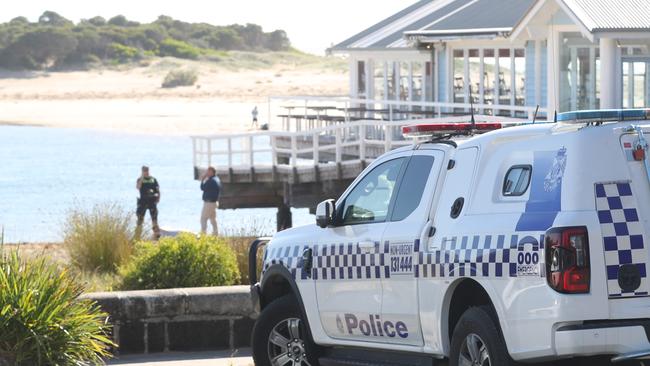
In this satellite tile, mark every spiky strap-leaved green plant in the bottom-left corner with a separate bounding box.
[0,252,115,366]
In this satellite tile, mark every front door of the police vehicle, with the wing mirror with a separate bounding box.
[312,151,410,342]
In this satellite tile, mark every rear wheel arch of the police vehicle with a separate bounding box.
[440,278,508,355]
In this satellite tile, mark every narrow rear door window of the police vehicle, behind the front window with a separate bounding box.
[391,155,433,221]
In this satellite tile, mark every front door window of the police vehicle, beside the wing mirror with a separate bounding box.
[339,158,404,225]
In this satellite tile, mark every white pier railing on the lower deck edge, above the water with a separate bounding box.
[192,120,413,171]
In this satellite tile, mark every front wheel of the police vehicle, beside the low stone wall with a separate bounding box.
[252,295,318,366]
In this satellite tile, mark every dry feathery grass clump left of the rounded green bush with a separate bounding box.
[63,203,136,272]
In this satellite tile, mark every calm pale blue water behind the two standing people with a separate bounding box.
[0,126,313,242]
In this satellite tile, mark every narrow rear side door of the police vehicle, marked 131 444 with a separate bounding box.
[380,150,445,345]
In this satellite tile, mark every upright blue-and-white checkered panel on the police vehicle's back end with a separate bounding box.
[595,182,650,298]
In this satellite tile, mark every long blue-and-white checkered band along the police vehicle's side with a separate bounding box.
[264,234,545,281]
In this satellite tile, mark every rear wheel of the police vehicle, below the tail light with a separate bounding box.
[449,306,515,366]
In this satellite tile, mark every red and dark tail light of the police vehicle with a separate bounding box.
[545,226,591,294]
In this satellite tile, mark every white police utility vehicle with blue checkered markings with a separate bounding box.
[246,109,650,366]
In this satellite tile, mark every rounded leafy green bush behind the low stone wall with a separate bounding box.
[120,233,239,290]
